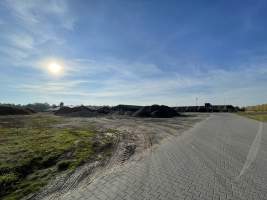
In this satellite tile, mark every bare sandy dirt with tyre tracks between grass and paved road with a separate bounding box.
[30,113,208,200]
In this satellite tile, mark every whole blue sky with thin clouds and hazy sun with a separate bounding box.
[0,0,267,106]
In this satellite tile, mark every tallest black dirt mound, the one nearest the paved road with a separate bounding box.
[133,105,179,118]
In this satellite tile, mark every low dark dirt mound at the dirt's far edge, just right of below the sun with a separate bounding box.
[55,106,98,117]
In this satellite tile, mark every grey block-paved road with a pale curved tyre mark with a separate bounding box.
[53,114,267,200]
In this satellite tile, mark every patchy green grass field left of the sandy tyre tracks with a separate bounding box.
[0,115,114,200]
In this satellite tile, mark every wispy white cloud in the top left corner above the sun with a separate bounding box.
[0,0,76,66]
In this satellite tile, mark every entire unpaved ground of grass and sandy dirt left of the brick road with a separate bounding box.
[0,113,204,200]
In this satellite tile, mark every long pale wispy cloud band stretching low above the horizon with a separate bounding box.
[12,55,267,105]
